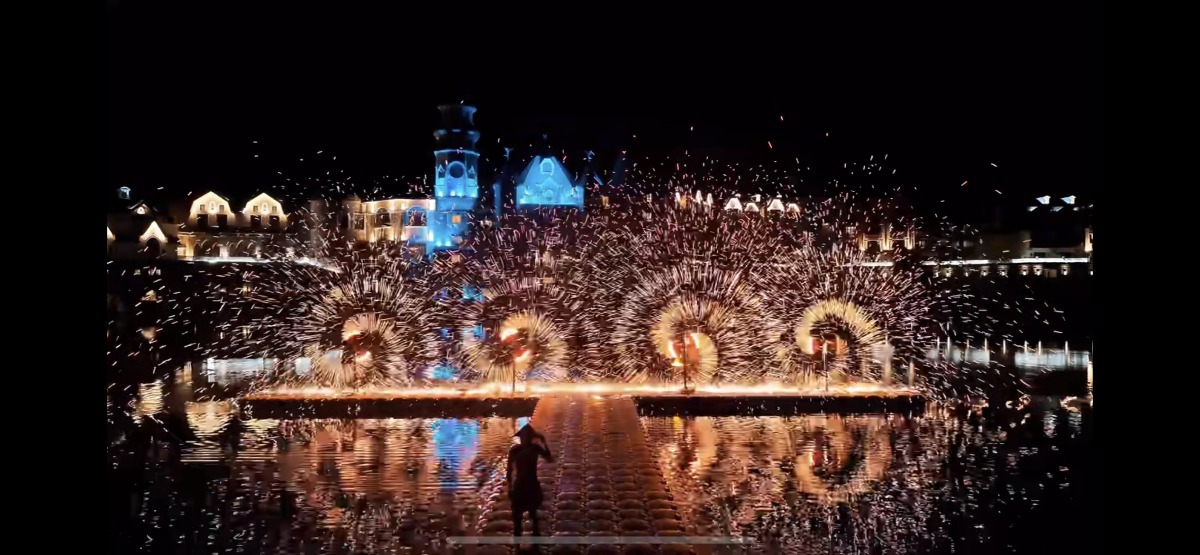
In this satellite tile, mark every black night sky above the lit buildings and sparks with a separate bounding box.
[106,1,1093,216]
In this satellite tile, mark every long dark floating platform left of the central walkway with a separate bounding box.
[239,395,539,419]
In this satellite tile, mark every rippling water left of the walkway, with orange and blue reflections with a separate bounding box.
[109,370,521,553]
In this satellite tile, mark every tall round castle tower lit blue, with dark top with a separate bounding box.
[430,105,479,250]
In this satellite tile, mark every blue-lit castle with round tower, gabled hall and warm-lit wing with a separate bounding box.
[342,105,592,256]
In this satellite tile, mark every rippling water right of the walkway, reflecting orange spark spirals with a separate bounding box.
[643,400,1091,553]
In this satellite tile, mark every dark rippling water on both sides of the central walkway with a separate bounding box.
[108,370,1092,554]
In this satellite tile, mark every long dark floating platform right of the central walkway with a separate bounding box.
[634,392,928,416]
